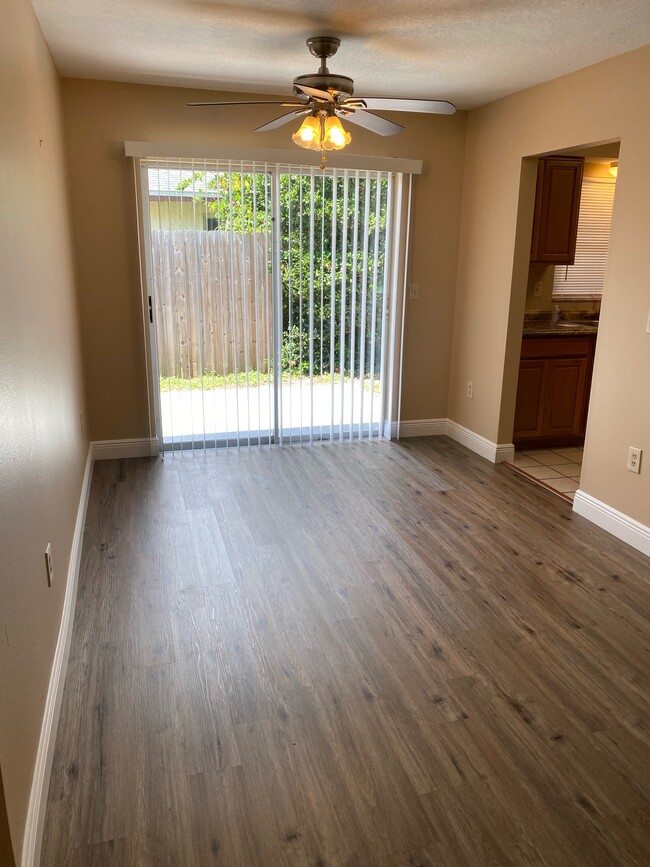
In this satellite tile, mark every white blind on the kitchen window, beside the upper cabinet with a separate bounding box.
[553,178,616,298]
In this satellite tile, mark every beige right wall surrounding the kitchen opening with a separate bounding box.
[449,47,650,525]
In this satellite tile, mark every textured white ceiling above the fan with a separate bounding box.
[32,0,650,108]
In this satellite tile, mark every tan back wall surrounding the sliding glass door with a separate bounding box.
[63,79,466,439]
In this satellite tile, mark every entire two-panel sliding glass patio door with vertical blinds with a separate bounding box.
[141,159,406,451]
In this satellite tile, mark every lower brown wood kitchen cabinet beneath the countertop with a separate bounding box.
[513,335,596,448]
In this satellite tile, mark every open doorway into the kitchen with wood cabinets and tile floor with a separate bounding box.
[509,142,619,501]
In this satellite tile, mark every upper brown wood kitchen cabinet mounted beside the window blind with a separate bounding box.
[530,157,585,265]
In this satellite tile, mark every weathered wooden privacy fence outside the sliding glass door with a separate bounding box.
[151,229,272,379]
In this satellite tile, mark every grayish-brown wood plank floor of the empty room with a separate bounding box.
[42,437,650,867]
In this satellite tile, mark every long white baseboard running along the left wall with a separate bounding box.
[20,445,93,867]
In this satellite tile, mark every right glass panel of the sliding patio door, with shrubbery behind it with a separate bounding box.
[277,169,390,441]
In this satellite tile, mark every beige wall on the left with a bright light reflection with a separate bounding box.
[0,0,87,860]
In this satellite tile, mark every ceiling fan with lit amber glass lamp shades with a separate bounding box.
[188,36,456,161]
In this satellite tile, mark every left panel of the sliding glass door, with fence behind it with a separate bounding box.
[145,160,273,450]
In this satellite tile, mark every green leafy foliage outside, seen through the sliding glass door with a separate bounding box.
[178,171,388,375]
